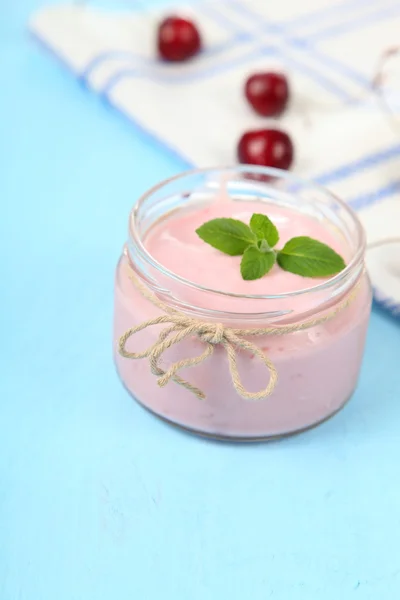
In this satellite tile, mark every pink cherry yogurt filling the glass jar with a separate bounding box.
[114,199,371,439]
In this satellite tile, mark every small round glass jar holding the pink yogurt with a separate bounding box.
[114,166,371,440]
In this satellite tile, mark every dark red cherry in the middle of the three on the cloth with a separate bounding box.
[245,73,289,117]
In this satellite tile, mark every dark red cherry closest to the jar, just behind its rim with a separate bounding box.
[237,129,294,169]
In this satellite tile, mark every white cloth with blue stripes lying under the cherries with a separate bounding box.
[30,0,400,312]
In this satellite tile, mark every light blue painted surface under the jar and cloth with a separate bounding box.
[0,0,400,600]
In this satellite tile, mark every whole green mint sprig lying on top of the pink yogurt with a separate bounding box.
[196,214,346,280]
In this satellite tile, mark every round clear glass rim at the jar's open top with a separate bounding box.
[129,164,366,300]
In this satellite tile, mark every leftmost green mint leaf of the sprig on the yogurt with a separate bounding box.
[196,218,257,256]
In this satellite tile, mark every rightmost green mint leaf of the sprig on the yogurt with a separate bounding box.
[277,236,346,277]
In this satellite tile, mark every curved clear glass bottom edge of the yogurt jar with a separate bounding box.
[121,379,353,444]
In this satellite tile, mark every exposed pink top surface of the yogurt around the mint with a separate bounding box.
[145,201,346,295]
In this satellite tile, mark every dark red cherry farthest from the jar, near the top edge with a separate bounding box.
[157,16,201,62]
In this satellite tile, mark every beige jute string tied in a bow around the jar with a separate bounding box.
[119,267,360,400]
